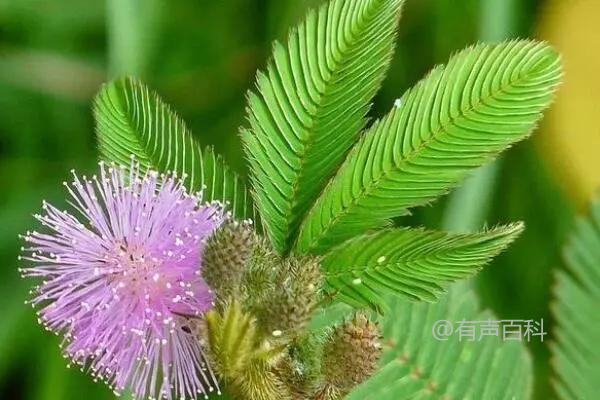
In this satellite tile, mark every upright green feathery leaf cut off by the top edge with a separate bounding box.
[242,0,403,253]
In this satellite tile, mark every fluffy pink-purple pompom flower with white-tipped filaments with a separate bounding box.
[21,162,223,399]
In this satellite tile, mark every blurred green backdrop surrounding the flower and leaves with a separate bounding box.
[0,0,600,400]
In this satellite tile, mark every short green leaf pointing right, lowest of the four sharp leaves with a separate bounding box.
[321,224,523,310]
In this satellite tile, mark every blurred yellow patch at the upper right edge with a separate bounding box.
[537,0,600,205]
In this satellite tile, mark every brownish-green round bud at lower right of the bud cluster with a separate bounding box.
[323,313,381,396]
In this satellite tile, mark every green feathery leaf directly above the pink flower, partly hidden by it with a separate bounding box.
[94,78,255,219]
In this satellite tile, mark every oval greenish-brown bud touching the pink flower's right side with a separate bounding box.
[202,220,256,302]
